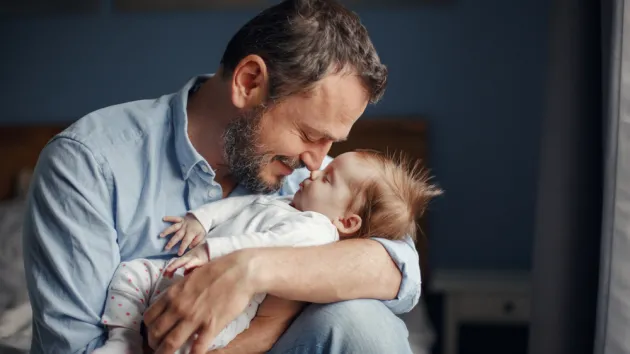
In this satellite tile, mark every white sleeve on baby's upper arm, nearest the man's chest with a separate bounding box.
[190,195,260,233]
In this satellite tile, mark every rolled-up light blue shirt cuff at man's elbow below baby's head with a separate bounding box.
[373,238,421,314]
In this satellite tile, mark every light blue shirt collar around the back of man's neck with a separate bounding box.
[171,74,213,179]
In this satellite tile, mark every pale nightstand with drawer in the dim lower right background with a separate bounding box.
[431,270,531,354]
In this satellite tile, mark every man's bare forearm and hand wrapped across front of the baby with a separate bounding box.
[144,239,419,354]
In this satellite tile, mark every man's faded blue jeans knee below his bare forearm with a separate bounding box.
[269,300,411,354]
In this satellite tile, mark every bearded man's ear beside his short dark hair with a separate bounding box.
[232,55,269,109]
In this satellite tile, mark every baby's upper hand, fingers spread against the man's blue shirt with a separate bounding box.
[160,214,206,256]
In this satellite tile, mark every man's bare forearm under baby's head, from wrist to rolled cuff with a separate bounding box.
[249,239,410,303]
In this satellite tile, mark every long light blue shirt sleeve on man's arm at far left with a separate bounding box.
[23,137,120,353]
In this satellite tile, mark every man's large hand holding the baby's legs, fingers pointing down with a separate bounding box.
[144,251,257,354]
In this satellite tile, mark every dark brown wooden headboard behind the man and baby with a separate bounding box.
[0,117,428,284]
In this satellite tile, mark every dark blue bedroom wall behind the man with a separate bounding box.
[0,0,548,269]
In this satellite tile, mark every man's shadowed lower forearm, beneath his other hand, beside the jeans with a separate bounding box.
[210,296,305,354]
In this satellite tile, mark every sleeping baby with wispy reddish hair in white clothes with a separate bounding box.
[95,150,441,353]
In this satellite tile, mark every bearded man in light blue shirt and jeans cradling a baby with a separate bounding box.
[24,0,420,353]
